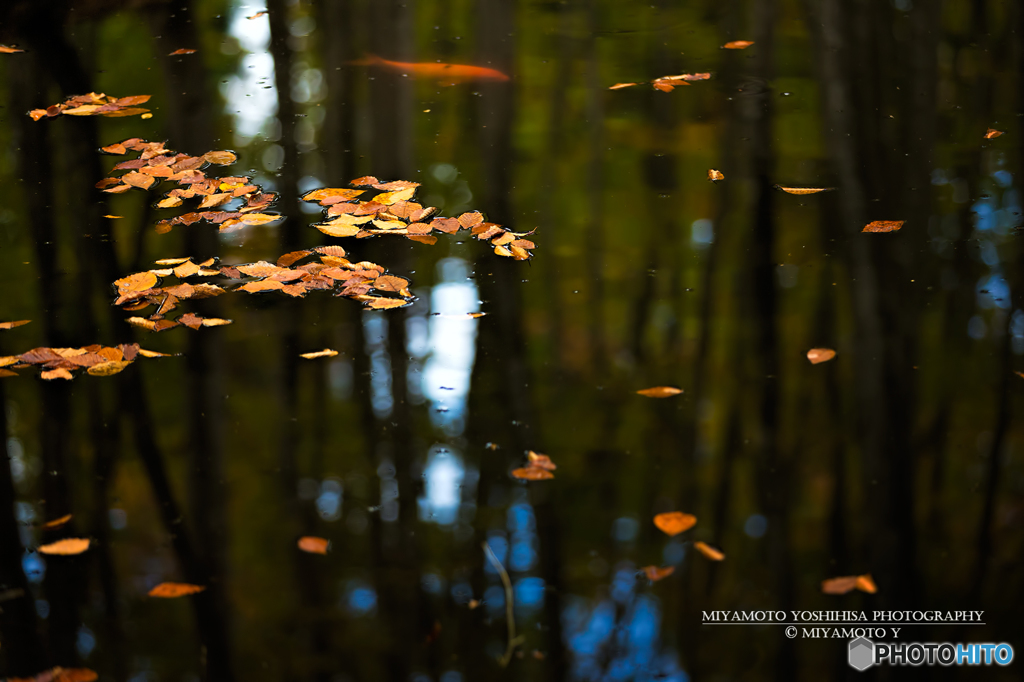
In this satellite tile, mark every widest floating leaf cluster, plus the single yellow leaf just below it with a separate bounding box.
[114,246,413,325]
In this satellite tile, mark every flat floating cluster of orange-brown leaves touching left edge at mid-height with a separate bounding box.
[0,343,169,380]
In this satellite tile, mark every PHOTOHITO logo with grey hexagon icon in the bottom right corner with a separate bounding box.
[847,637,1014,671]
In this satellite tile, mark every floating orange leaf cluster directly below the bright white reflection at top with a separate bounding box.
[96,137,282,233]
